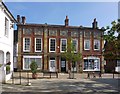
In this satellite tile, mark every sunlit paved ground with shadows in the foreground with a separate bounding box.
[2,73,120,94]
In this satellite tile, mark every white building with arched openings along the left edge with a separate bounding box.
[0,2,16,83]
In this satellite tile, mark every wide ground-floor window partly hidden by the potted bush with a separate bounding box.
[23,56,42,70]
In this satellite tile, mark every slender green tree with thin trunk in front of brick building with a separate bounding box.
[62,39,82,78]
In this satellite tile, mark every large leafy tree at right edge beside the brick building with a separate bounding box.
[104,19,120,60]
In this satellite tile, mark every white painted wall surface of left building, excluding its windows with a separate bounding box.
[0,2,14,82]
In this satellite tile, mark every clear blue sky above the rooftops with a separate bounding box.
[5,2,120,28]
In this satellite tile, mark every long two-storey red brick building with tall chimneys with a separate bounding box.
[17,15,104,72]
